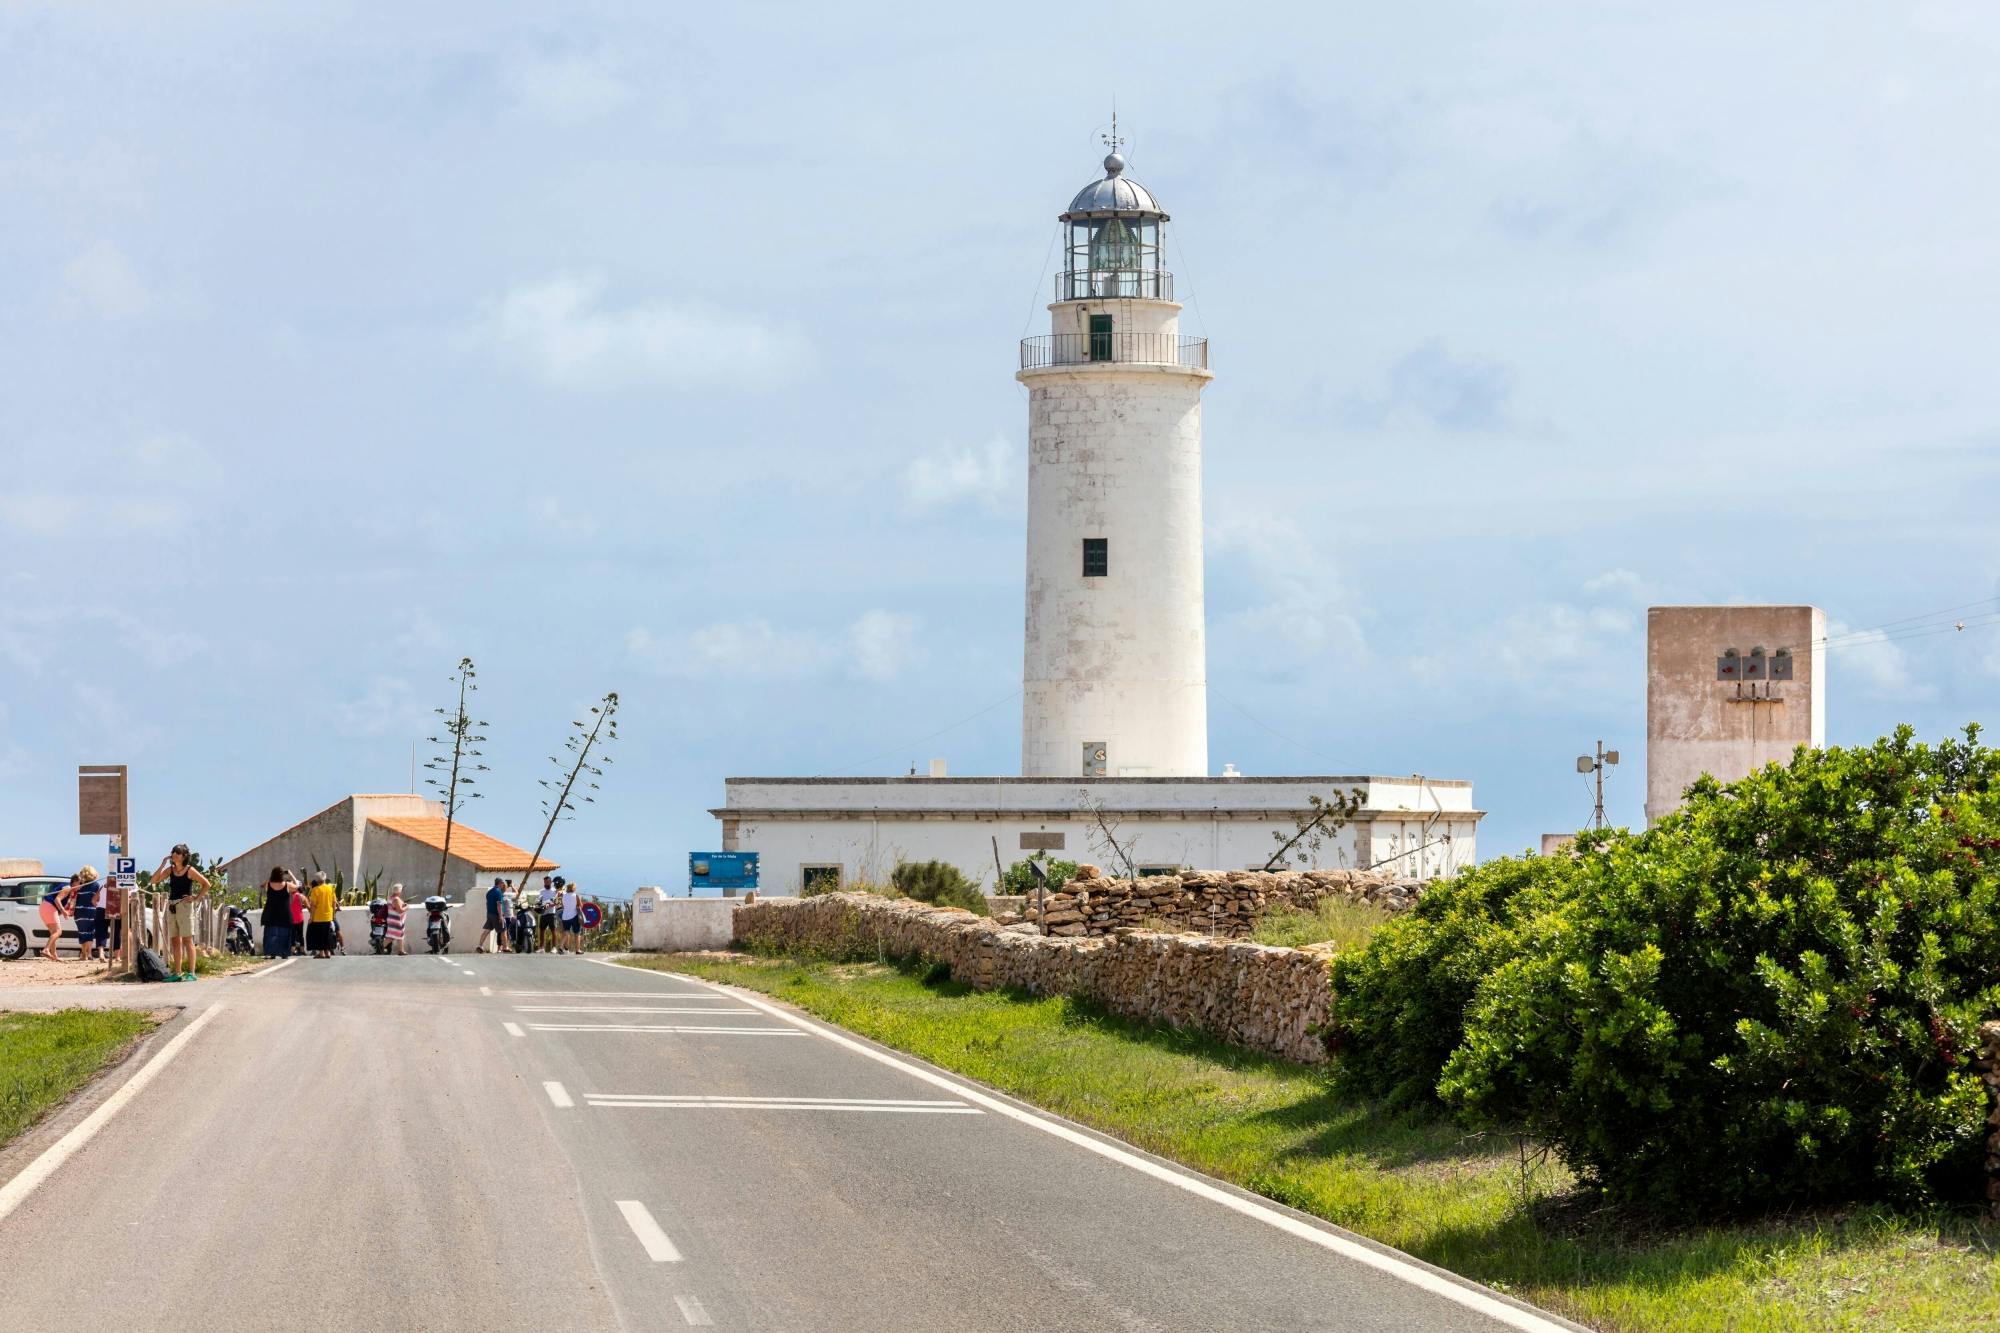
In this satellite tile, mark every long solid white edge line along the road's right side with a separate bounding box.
[590,959,1564,1333]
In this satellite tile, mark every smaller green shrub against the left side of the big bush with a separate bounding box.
[1330,857,1576,1103]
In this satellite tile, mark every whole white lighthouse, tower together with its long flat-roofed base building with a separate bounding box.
[694,140,1482,895]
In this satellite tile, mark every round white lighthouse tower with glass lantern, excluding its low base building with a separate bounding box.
[1016,140,1214,777]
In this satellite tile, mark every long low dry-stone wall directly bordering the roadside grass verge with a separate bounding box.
[736,881,1360,1065]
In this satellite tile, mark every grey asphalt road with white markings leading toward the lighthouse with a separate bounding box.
[0,955,1576,1333]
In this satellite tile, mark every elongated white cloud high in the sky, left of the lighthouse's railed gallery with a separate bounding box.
[472,274,810,390]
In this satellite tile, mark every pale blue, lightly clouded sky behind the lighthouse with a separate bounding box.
[0,0,2000,893]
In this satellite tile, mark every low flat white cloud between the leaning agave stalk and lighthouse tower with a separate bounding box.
[626,610,922,681]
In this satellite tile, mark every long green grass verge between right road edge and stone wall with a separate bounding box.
[626,957,2000,1333]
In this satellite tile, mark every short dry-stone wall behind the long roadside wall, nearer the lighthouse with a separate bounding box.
[1016,865,1422,939]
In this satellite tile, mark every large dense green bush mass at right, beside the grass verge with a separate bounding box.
[1336,729,2000,1211]
